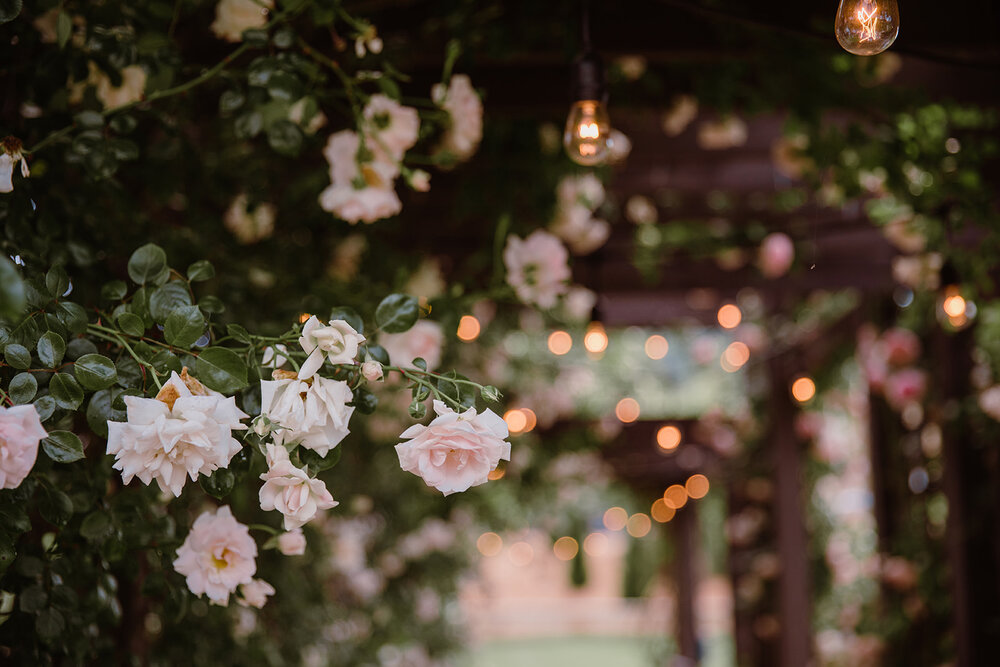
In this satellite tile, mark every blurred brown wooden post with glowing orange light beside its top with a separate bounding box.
[768,356,812,667]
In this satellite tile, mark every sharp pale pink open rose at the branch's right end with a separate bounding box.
[396,401,510,496]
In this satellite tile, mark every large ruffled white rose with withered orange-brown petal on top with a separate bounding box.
[108,368,250,496]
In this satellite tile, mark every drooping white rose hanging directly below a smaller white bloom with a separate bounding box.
[260,371,354,456]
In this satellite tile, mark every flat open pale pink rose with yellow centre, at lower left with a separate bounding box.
[174,505,257,606]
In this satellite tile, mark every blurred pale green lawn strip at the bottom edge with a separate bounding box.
[471,637,657,667]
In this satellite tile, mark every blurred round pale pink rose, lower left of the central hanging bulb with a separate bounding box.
[503,229,571,308]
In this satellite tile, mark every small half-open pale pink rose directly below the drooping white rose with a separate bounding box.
[260,445,339,530]
